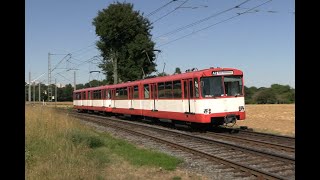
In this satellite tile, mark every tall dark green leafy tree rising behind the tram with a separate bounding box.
[92,2,156,84]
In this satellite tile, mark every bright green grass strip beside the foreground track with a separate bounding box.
[69,130,182,170]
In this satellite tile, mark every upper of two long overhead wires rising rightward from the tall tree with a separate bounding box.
[155,0,250,39]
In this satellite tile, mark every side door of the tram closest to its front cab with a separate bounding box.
[182,79,195,114]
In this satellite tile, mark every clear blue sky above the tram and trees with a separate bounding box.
[25,0,295,88]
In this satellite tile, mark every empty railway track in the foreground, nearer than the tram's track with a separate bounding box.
[65,109,295,179]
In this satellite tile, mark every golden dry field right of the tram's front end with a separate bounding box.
[237,104,295,136]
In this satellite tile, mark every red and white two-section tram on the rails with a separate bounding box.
[73,67,245,125]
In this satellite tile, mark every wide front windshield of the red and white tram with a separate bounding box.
[201,76,243,98]
